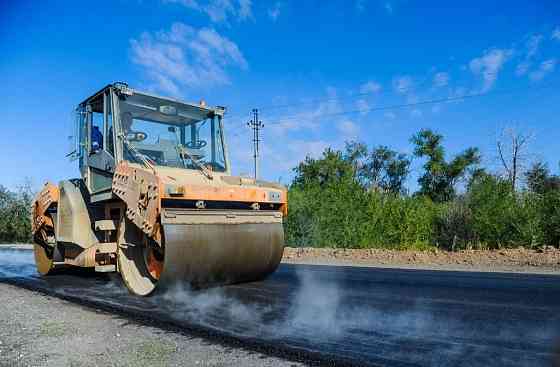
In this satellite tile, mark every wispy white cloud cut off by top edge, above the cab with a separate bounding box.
[163,0,253,23]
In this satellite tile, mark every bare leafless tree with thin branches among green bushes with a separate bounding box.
[496,128,532,191]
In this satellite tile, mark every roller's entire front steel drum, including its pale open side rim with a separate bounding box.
[118,209,284,296]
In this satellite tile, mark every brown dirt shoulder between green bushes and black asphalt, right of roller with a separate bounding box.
[282,247,560,273]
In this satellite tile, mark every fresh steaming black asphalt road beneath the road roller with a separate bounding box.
[0,250,560,367]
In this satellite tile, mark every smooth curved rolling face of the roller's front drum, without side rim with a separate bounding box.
[157,218,284,288]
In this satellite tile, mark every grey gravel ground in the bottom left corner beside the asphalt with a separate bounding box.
[0,283,300,367]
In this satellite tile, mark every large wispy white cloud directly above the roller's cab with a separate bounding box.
[130,23,248,95]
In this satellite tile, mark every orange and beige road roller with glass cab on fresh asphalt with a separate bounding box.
[32,82,287,296]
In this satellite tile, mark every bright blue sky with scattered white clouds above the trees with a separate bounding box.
[0,0,560,188]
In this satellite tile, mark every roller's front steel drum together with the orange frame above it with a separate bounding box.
[112,162,287,295]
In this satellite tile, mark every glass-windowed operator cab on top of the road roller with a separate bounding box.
[71,83,229,200]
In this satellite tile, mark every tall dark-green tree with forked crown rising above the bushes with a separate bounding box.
[411,129,480,202]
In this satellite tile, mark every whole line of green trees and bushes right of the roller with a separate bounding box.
[285,129,560,250]
